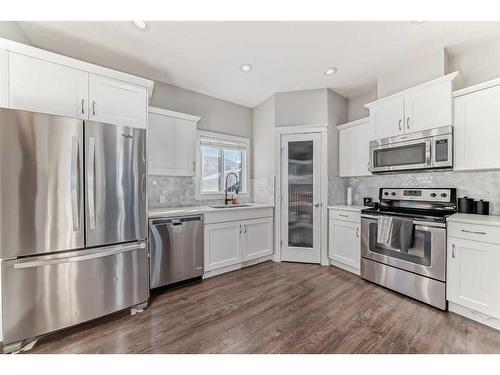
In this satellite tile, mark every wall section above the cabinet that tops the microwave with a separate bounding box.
[377,49,446,99]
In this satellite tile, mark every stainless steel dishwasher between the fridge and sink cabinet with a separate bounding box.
[149,216,203,289]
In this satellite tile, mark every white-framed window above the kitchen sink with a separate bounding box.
[196,131,250,199]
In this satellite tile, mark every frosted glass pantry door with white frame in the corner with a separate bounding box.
[281,133,322,263]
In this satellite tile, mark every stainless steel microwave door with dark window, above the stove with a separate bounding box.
[370,138,432,173]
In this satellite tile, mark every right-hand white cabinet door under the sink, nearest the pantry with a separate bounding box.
[242,217,274,261]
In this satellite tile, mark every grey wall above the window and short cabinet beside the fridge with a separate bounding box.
[151,82,252,138]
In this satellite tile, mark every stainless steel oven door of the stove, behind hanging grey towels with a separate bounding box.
[361,215,446,281]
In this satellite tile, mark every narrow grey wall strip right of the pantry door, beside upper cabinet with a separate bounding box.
[327,90,347,176]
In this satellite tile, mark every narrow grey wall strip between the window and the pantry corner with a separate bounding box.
[252,95,275,178]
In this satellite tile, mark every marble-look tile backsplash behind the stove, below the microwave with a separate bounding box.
[350,171,500,215]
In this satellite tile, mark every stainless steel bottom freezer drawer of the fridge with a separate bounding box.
[2,242,149,344]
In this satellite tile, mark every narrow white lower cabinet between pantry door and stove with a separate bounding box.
[328,210,361,275]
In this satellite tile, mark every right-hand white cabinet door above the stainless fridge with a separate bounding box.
[89,74,148,129]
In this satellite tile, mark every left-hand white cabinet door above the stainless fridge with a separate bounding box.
[9,52,89,119]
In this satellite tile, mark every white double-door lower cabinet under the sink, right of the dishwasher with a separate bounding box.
[204,212,274,277]
